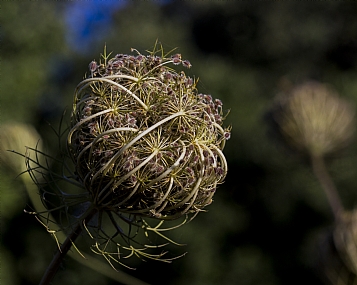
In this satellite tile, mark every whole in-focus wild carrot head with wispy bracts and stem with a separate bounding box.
[14,44,231,284]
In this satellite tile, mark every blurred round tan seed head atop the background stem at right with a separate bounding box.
[273,82,354,156]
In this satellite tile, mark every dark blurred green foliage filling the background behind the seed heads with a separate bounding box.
[0,1,357,285]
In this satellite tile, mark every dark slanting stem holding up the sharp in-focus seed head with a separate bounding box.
[39,206,96,285]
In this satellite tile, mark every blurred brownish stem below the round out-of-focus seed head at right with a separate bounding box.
[311,156,343,220]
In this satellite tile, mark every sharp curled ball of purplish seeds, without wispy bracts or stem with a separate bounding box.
[68,46,230,219]
